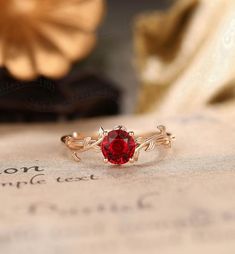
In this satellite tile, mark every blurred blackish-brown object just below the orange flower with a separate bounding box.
[0,70,121,122]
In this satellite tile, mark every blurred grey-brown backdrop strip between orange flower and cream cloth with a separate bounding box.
[98,0,173,113]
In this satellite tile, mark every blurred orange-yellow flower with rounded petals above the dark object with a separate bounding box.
[0,0,104,79]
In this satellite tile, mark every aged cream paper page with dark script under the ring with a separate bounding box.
[0,107,235,254]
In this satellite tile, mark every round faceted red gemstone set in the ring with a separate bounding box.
[101,129,136,164]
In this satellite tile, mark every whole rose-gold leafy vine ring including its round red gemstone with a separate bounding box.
[61,125,174,165]
